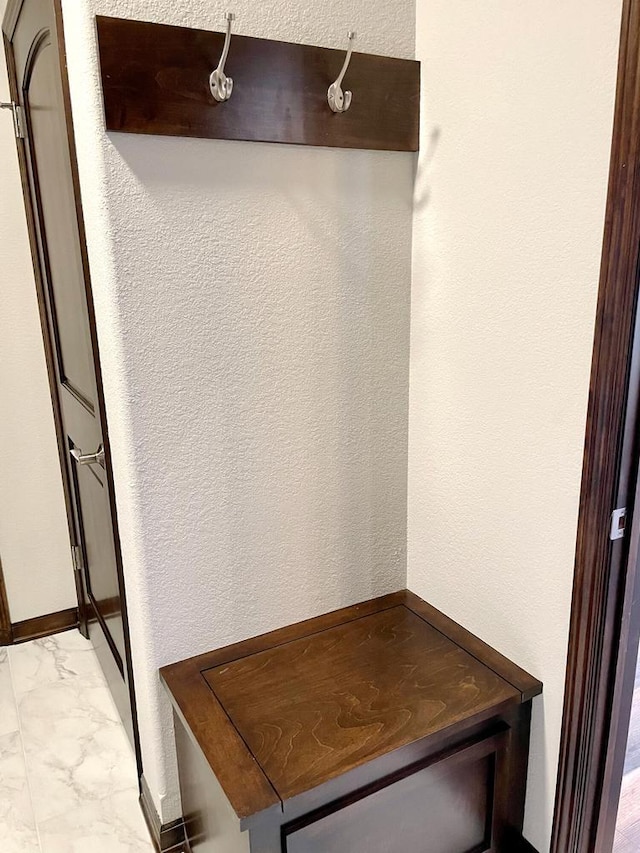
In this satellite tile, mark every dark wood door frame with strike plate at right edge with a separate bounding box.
[551,0,640,853]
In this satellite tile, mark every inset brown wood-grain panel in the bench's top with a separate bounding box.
[203,606,521,799]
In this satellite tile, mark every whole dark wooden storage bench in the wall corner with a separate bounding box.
[161,592,541,853]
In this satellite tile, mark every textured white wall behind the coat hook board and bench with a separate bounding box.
[64,0,415,820]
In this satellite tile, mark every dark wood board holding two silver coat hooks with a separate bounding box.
[97,17,420,151]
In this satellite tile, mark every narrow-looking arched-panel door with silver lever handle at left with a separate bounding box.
[4,0,139,756]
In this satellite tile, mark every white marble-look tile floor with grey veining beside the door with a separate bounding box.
[0,631,153,853]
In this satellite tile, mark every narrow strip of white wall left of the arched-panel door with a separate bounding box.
[0,35,76,622]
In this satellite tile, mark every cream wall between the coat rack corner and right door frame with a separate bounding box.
[408,0,621,851]
